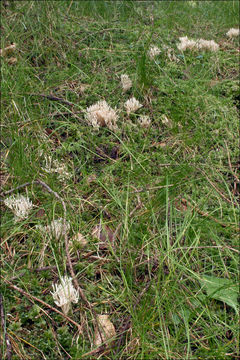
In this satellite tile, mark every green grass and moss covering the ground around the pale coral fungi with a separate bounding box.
[0,1,240,360]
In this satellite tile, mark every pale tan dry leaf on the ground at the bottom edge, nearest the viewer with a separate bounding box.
[93,315,116,346]
